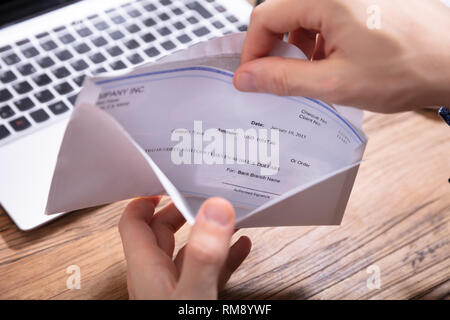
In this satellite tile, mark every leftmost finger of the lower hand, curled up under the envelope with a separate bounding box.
[119,198,176,299]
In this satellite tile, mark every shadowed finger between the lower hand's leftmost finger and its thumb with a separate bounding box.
[150,203,186,257]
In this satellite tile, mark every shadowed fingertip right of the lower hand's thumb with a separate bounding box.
[219,236,252,289]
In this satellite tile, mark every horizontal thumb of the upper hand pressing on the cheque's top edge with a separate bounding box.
[234,57,342,99]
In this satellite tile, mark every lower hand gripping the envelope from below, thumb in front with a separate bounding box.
[119,198,251,299]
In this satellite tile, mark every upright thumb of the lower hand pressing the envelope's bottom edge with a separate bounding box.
[176,198,234,299]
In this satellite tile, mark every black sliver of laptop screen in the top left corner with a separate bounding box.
[0,0,79,28]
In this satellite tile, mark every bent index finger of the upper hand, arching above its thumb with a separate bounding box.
[241,0,331,63]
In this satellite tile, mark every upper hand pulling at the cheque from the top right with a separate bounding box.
[234,0,450,113]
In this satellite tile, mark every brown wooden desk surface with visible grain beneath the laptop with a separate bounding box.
[0,111,450,299]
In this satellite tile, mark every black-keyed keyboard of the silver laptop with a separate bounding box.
[0,0,250,145]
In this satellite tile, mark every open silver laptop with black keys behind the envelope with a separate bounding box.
[0,0,252,230]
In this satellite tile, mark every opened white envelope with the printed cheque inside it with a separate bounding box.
[47,34,367,227]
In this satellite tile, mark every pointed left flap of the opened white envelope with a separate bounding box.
[46,104,164,214]
